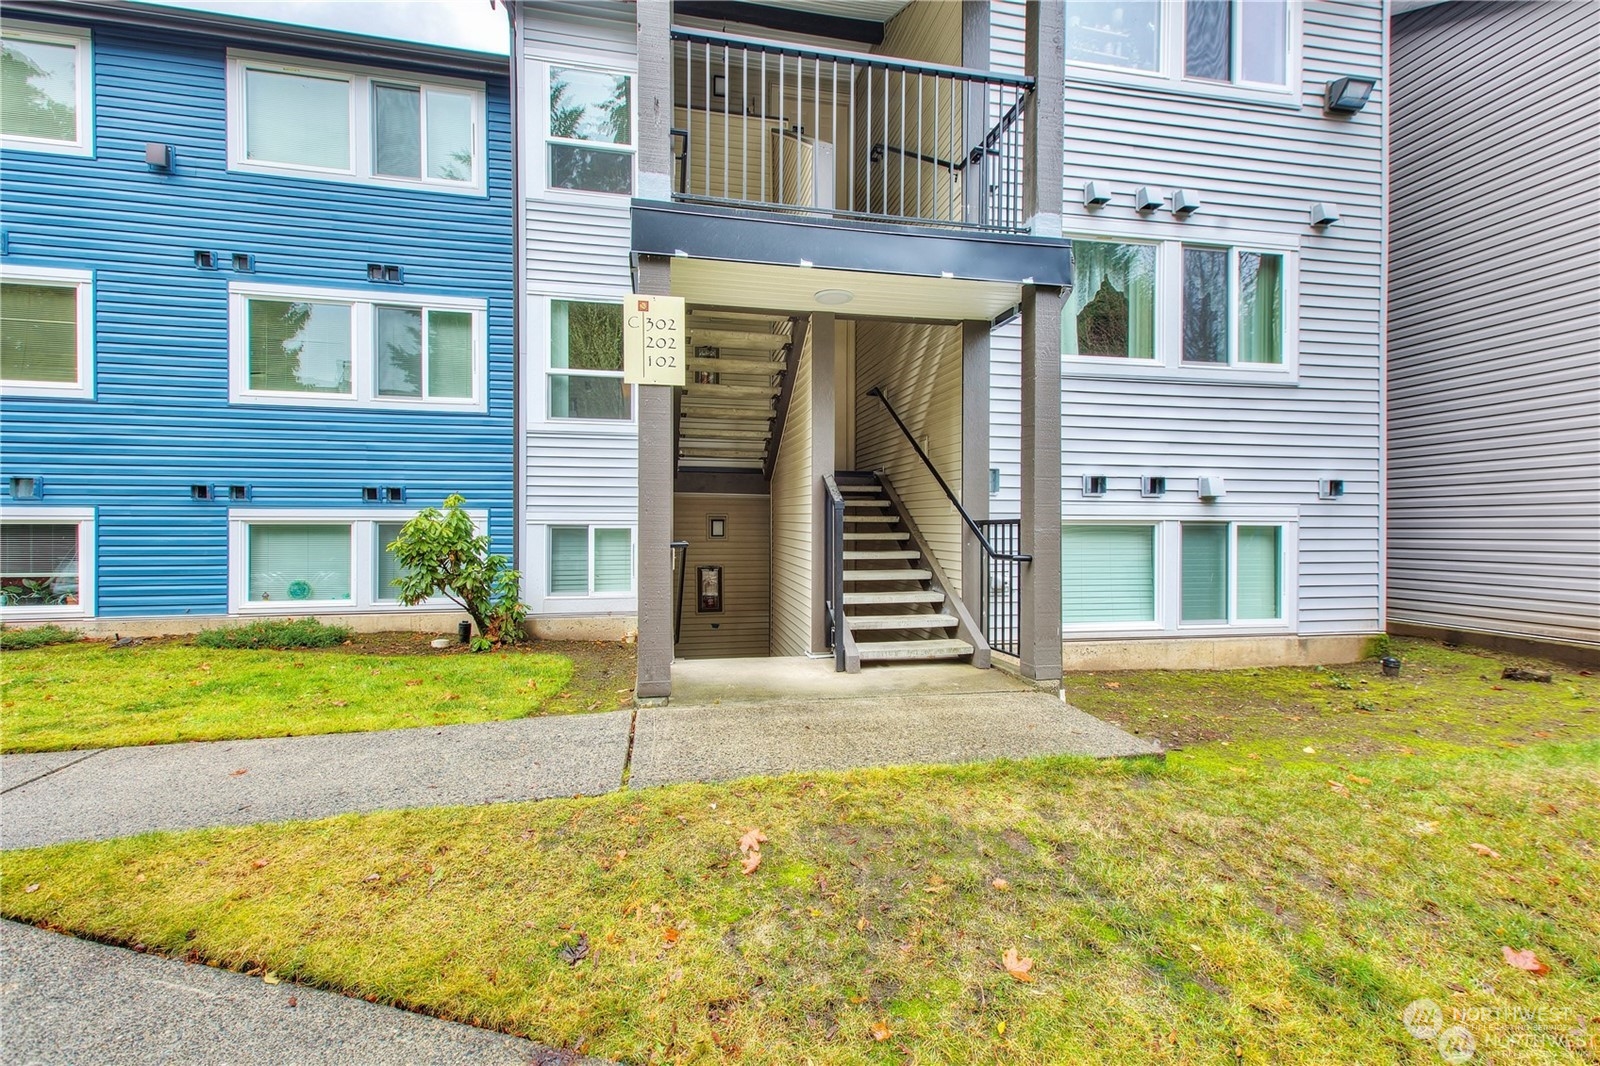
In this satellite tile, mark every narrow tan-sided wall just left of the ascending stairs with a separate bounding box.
[771,330,816,655]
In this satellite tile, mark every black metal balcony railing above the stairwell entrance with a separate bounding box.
[672,29,1034,232]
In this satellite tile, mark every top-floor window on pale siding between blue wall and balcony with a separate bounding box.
[546,64,634,195]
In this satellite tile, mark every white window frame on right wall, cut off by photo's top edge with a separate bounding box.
[1067,0,1304,109]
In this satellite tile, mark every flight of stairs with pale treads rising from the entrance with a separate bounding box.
[830,471,990,672]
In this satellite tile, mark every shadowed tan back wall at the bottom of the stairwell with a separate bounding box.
[672,493,771,659]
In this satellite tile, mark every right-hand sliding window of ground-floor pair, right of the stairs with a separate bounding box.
[1179,522,1283,624]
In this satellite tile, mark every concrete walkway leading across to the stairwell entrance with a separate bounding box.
[0,659,1158,848]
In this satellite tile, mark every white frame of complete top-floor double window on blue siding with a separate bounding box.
[227,48,488,197]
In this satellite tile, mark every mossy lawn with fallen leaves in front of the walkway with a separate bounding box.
[0,633,1600,1064]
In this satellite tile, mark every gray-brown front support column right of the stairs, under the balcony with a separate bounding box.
[1019,284,1064,680]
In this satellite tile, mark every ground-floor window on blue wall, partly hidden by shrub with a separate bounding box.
[229,509,488,613]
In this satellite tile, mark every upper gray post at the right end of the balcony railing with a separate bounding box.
[1022,0,1067,237]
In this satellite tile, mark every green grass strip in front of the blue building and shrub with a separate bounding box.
[0,634,634,752]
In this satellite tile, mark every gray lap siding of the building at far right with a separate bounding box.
[1389,2,1600,643]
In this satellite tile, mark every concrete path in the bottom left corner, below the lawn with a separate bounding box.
[0,922,594,1066]
